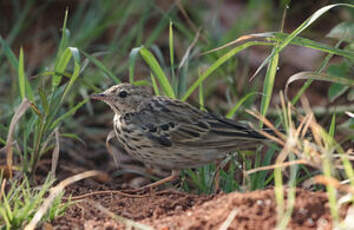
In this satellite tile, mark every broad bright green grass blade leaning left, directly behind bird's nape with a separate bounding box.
[139,47,176,98]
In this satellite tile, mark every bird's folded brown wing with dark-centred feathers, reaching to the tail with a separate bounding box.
[132,97,263,147]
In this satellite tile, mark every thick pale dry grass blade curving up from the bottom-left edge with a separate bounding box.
[24,170,105,230]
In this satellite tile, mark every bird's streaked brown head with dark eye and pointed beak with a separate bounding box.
[91,83,152,115]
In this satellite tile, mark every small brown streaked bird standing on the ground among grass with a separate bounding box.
[91,83,272,189]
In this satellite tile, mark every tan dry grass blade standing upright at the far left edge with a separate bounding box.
[5,98,31,178]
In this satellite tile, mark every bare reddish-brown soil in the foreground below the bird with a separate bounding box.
[50,180,338,230]
